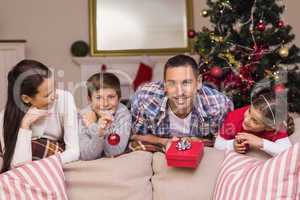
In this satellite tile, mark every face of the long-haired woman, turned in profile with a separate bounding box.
[22,77,57,109]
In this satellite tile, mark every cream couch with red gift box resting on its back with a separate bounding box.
[64,118,300,200]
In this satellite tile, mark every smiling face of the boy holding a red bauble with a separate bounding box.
[89,88,120,115]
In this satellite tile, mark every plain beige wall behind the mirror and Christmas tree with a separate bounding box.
[0,0,300,106]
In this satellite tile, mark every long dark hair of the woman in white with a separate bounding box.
[1,60,51,173]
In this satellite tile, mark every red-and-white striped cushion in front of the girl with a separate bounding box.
[214,143,300,200]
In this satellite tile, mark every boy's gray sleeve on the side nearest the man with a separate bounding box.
[104,110,131,157]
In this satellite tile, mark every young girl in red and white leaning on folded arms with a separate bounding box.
[215,93,293,156]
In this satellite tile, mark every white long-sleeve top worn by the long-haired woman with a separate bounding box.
[0,89,79,166]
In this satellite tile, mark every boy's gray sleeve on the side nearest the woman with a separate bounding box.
[79,120,104,160]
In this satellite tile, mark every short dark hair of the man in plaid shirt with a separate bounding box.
[164,54,200,79]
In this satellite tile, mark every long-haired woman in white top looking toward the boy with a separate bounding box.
[0,60,79,172]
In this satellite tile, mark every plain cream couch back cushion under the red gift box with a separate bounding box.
[152,148,224,200]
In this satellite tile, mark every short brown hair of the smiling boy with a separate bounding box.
[86,72,122,99]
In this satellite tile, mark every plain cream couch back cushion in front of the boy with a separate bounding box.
[64,151,153,200]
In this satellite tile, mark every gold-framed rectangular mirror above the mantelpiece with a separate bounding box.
[89,0,193,56]
